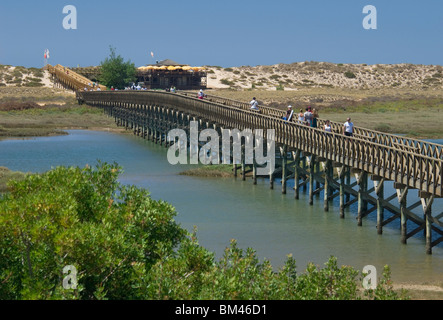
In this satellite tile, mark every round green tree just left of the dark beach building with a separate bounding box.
[100,46,137,89]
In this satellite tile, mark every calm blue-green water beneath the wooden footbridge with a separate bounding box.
[0,130,443,282]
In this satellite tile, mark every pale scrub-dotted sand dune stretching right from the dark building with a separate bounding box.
[207,62,443,90]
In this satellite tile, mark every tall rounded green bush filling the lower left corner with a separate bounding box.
[0,163,186,300]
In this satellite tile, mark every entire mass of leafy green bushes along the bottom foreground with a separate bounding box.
[0,163,410,300]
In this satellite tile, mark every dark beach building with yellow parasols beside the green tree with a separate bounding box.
[137,59,207,90]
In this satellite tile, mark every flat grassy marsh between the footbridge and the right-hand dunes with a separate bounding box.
[206,86,443,139]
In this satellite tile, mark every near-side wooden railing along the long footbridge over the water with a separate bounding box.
[79,91,443,196]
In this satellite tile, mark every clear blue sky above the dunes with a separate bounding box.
[0,0,443,67]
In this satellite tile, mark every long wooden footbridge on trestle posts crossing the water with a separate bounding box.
[48,67,443,254]
